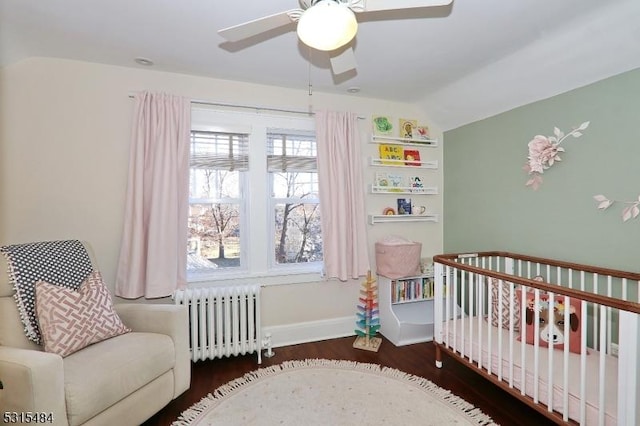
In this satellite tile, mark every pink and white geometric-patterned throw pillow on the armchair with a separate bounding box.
[36,271,131,357]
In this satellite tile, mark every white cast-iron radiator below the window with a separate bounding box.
[173,285,262,364]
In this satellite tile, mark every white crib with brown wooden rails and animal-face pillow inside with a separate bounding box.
[434,252,640,425]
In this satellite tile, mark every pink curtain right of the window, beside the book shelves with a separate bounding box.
[316,111,369,281]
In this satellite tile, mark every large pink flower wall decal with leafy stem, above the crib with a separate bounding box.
[523,121,589,191]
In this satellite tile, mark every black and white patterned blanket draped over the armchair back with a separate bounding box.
[0,240,93,344]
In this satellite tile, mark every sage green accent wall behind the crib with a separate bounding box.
[443,69,640,271]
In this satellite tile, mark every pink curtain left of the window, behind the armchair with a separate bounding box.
[116,92,191,299]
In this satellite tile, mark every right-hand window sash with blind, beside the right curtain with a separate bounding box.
[267,129,322,265]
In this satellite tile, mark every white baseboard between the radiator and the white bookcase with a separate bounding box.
[262,316,356,348]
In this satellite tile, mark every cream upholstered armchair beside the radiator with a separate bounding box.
[0,243,191,425]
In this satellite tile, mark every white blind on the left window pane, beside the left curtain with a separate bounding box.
[190,130,249,171]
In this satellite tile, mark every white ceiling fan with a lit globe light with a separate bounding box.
[218,0,453,75]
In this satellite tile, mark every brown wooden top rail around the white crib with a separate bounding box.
[433,251,640,314]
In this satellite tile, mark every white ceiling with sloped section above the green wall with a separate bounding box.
[0,0,640,130]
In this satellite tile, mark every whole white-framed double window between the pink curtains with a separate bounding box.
[187,108,322,281]
